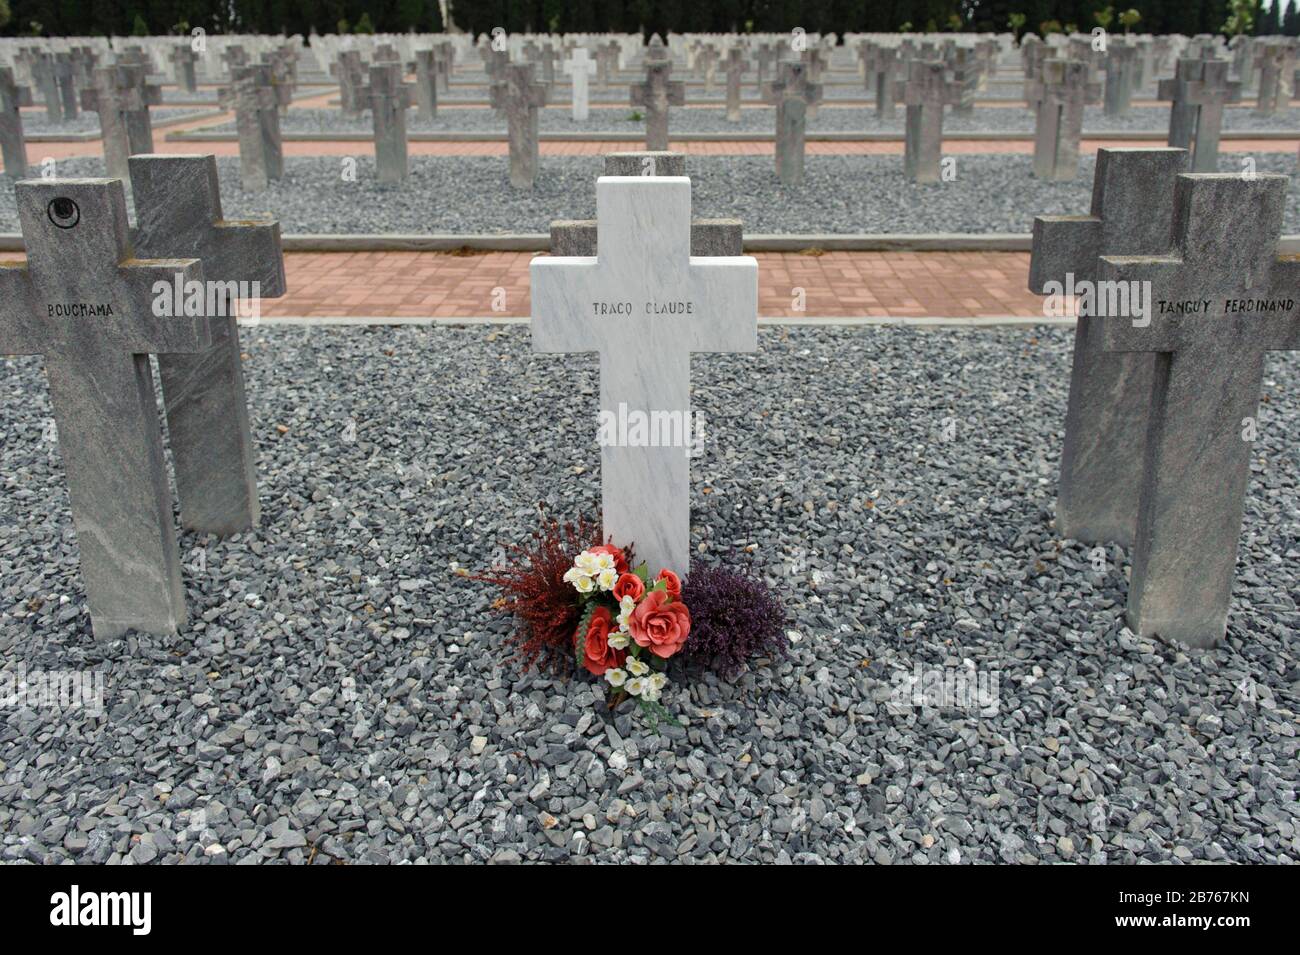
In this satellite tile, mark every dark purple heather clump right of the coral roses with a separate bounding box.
[681,567,788,680]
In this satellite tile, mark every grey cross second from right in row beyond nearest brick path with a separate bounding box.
[1026,60,1101,182]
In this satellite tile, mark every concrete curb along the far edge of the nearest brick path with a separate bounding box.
[0,233,1300,255]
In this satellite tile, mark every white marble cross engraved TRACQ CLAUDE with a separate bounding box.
[530,175,758,574]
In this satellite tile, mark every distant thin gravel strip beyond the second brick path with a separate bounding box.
[218,107,1300,136]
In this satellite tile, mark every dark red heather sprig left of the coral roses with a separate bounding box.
[471,517,634,672]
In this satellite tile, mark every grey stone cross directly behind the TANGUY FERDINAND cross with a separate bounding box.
[1030,148,1187,547]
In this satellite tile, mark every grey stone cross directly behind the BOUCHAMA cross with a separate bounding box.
[131,155,285,537]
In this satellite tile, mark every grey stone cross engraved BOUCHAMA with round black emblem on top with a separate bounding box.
[0,179,212,639]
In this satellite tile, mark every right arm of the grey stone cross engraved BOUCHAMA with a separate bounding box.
[114,259,212,355]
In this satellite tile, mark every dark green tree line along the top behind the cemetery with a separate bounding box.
[0,0,1300,36]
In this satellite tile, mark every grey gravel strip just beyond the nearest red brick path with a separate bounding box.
[0,153,1300,234]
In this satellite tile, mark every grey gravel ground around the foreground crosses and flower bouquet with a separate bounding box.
[0,327,1300,864]
